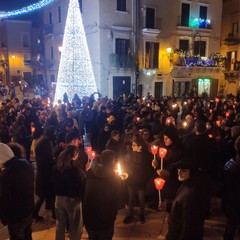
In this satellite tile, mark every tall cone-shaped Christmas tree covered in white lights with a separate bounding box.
[54,0,97,103]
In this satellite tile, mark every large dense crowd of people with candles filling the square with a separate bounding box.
[0,91,240,240]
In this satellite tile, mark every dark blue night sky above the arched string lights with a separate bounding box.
[0,0,40,11]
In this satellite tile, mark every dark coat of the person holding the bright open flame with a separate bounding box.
[83,162,122,231]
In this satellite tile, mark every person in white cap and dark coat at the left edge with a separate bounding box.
[0,142,34,240]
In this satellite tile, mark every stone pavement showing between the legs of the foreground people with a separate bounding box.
[0,198,240,240]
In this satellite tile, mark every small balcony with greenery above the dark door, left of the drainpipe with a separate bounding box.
[110,53,135,68]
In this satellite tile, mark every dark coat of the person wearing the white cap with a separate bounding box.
[0,157,34,225]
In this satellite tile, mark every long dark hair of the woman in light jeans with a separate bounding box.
[56,146,79,172]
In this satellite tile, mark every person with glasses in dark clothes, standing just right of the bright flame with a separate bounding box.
[123,137,153,224]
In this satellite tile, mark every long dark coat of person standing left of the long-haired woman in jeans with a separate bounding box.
[35,137,55,197]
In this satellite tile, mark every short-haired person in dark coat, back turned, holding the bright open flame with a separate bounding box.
[83,150,123,240]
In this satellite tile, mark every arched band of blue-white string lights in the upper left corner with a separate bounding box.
[0,0,55,19]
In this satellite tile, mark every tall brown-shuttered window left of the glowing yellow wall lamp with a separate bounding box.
[145,42,159,69]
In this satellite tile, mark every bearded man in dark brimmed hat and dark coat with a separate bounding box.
[166,156,211,240]
